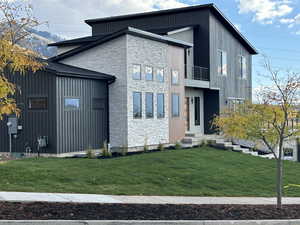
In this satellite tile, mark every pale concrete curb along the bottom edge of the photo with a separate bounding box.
[0,220,300,225]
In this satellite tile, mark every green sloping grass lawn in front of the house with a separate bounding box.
[0,148,300,196]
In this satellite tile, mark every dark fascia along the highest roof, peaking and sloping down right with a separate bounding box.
[85,3,258,55]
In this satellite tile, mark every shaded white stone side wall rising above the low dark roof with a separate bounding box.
[61,35,127,147]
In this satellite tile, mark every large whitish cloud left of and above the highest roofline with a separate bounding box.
[30,0,188,37]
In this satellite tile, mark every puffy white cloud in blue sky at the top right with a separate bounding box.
[236,0,293,24]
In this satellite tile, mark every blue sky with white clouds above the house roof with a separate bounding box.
[28,0,300,89]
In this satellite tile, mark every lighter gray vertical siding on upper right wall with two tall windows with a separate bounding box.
[209,11,252,107]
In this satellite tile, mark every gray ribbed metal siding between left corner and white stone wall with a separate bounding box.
[56,77,107,153]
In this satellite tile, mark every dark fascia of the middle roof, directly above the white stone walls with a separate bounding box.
[49,27,193,62]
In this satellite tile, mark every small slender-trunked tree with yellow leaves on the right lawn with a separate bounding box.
[214,59,300,208]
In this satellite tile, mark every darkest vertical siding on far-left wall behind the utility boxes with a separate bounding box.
[0,71,56,153]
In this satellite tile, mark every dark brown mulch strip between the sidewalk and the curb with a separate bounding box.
[0,202,300,220]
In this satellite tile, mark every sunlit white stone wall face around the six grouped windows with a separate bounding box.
[127,35,170,147]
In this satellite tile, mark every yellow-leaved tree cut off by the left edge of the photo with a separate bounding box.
[0,0,44,120]
